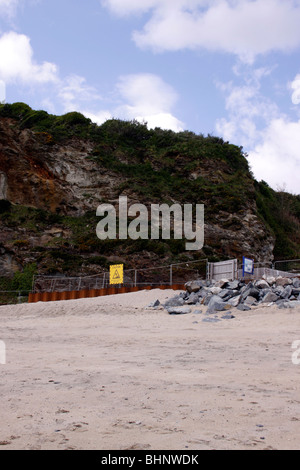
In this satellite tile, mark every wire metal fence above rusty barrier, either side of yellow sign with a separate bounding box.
[32,259,208,293]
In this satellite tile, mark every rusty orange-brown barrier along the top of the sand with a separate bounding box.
[28,284,185,303]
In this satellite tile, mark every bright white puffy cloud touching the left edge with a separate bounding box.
[0,31,58,84]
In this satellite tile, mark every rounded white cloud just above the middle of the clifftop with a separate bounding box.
[115,73,184,132]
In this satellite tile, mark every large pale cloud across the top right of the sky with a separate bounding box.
[104,0,300,63]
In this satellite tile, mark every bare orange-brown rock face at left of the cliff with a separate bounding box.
[0,119,120,214]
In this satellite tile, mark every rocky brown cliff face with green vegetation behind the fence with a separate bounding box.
[0,103,275,276]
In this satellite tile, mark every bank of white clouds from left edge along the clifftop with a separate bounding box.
[0,26,183,131]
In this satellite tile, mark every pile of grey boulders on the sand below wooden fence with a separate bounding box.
[158,277,300,314]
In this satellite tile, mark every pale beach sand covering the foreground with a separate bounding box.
[0,290,300,450]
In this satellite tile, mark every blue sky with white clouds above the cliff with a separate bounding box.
[0,0,300,194]
